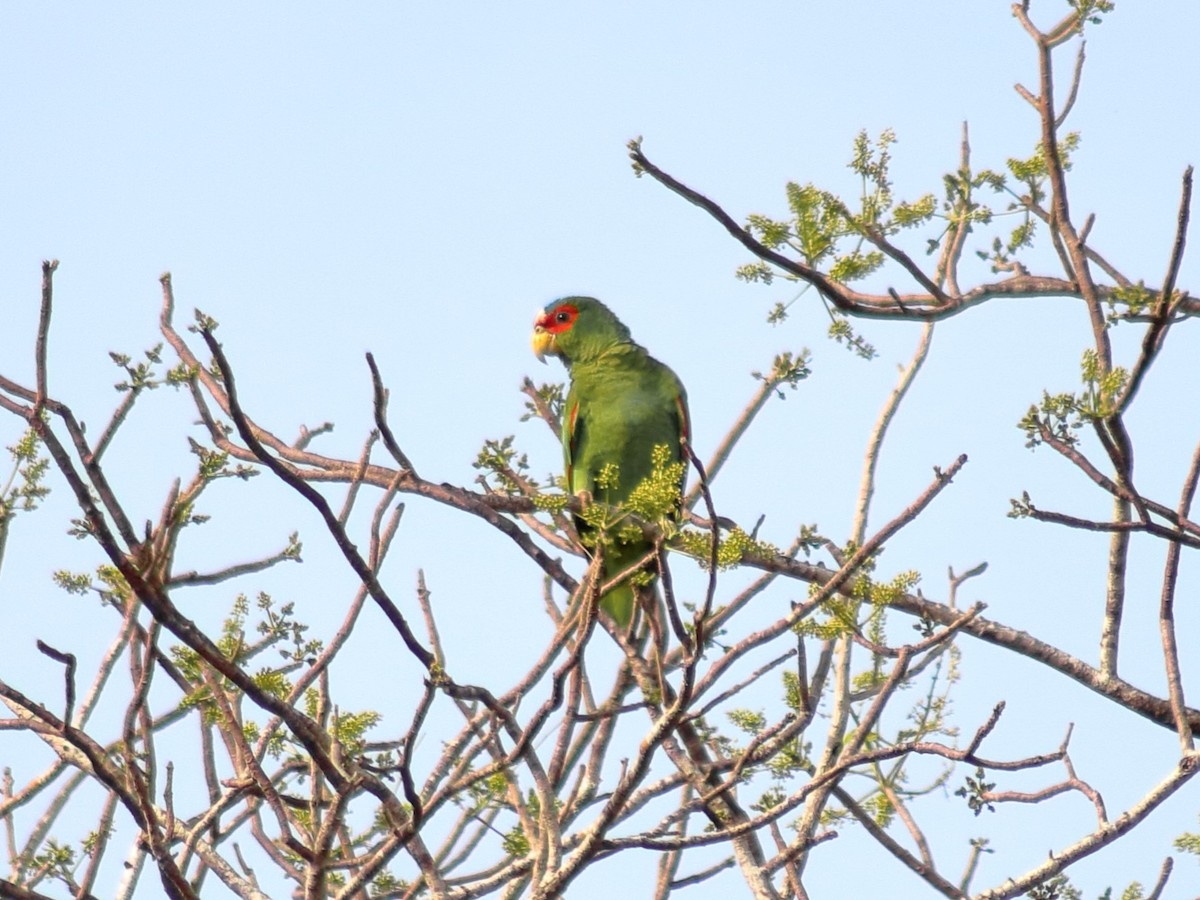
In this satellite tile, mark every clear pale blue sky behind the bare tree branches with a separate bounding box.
[0,0,1200,898]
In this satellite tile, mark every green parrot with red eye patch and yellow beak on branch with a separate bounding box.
[533,296,689,629]
